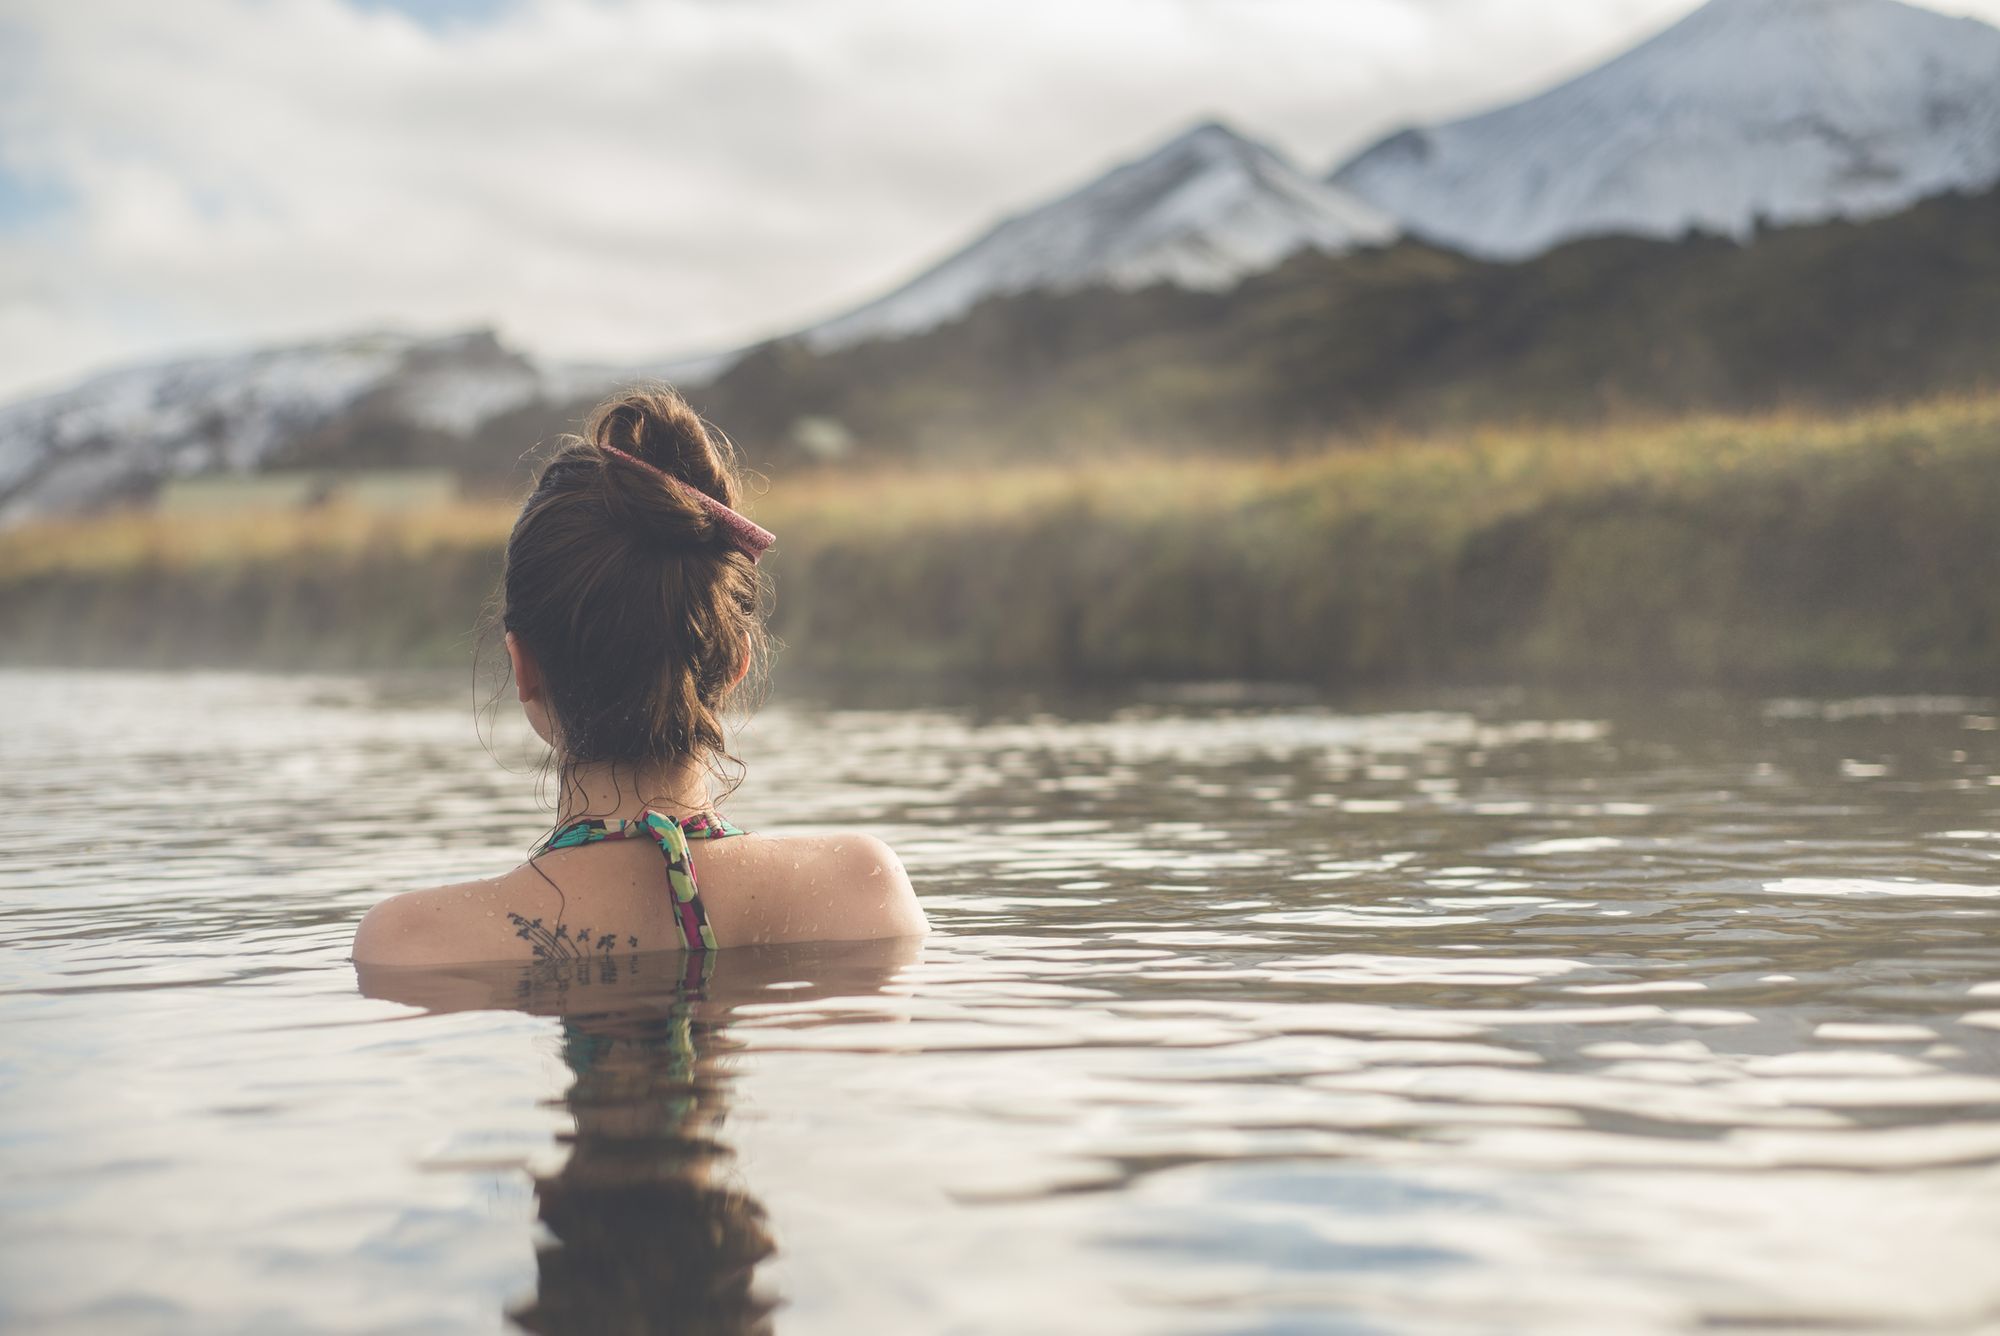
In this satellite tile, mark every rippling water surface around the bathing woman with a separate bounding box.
[0,674,2000,1334]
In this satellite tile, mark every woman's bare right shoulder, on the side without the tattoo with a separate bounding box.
[702,834,930,944]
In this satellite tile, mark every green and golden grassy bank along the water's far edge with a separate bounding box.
[11,396,2000,690]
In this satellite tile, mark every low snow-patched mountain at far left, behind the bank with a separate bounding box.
[0,330,620,522]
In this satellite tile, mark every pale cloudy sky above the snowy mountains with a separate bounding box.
[0,0,2000,398]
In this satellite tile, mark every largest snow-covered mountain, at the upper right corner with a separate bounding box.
[1330,0,2000,258]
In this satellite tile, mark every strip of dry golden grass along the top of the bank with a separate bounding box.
[15,394,2000,580]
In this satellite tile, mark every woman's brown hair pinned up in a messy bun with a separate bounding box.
[500,388,768,804]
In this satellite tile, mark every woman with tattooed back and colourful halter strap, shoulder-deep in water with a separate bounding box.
[354,392,926,966]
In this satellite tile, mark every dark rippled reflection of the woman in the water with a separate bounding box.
[360,942,922,1336]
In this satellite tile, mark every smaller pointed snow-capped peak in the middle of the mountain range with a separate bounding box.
[804,122,1396,348]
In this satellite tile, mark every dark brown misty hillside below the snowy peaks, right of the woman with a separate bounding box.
[692,181,2000,460]
